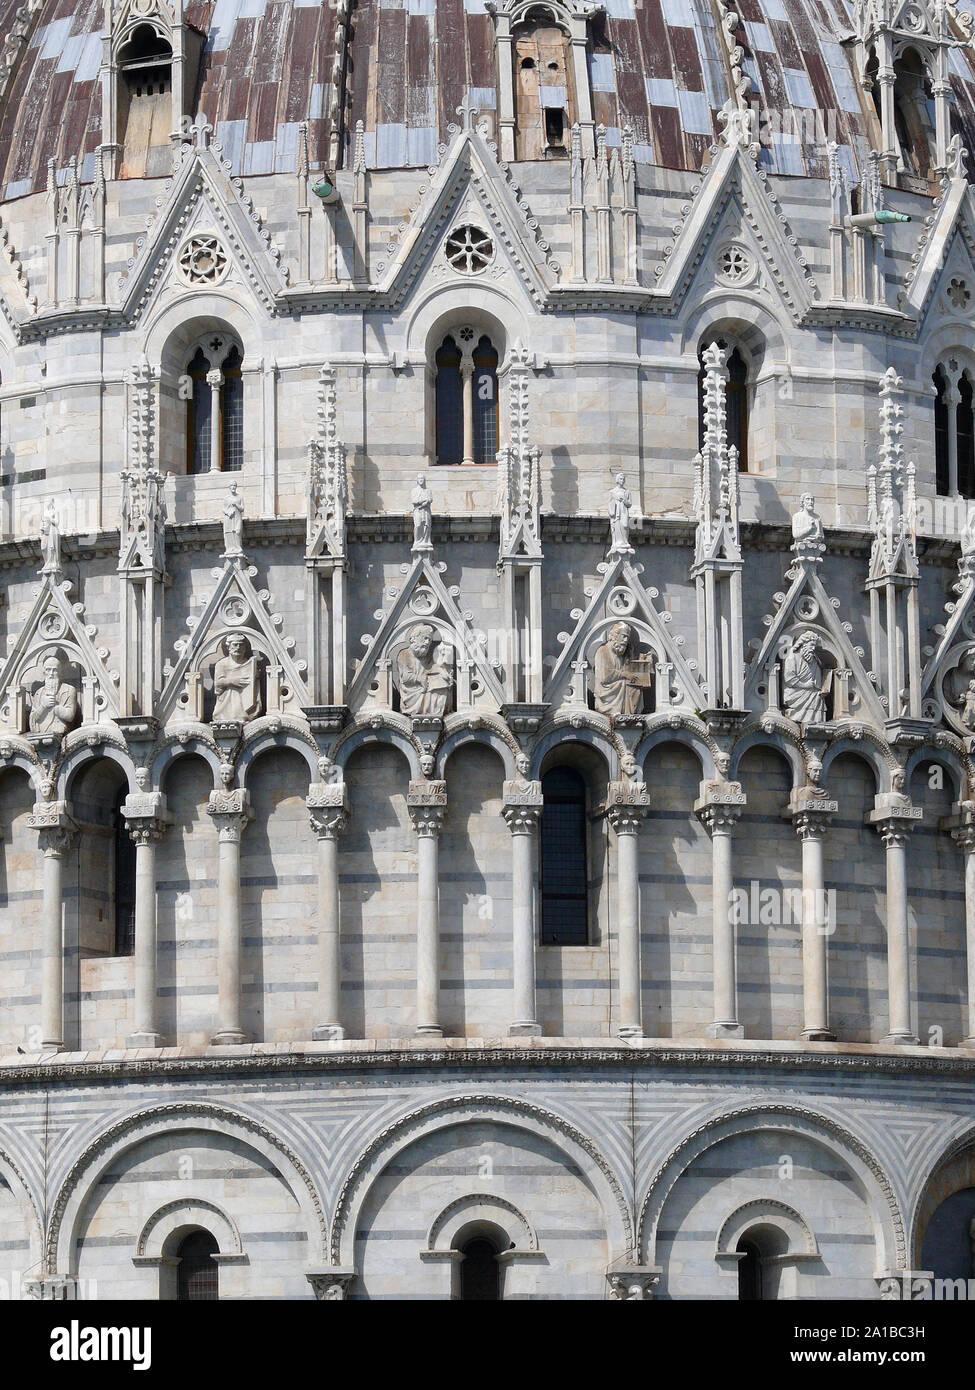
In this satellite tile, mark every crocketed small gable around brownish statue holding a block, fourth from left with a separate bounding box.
[544,555,707,713]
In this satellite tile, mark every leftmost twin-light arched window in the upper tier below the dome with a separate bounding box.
[185,334,243,473]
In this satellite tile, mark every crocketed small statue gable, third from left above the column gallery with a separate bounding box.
[348,555,505,717]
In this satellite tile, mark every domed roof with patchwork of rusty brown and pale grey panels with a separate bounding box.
[0,0,975,199]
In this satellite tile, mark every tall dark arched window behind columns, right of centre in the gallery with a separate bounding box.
[540,767,588,947]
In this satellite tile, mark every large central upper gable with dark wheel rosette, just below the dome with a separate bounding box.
[376,116,559,307]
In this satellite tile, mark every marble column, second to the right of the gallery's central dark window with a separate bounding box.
[694,781,746,1038]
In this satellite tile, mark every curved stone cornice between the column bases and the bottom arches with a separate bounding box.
[0,1037,975,1090]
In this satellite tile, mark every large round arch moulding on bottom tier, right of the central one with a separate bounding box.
[637,1104,907,1269]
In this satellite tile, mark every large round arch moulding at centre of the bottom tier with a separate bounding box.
[328,1093,633,1268]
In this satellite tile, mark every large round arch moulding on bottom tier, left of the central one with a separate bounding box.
[47,1101,327,1273]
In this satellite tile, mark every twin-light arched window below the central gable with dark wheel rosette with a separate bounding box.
[434,327,498,464]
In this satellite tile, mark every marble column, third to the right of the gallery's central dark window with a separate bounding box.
[789,787,839,1043]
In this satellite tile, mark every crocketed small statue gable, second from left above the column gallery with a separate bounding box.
[159,556,309,724]
